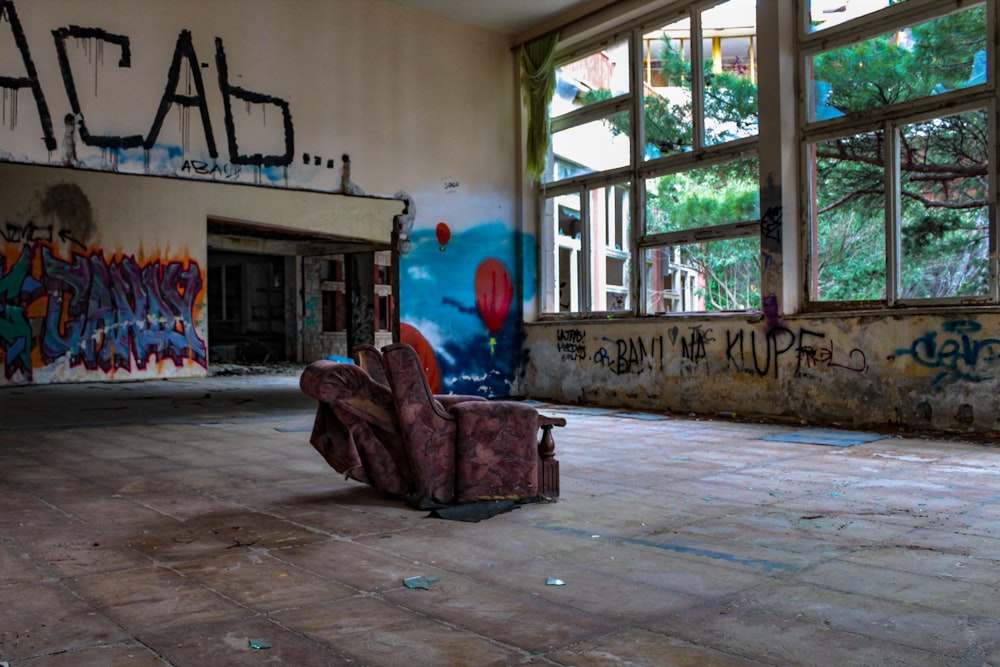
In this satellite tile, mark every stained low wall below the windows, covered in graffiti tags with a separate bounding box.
[525,310,1000,433]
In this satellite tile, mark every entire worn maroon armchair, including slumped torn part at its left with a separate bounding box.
[299,345,566,508]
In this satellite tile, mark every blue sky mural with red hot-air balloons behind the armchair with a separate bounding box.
[400,222,535,397]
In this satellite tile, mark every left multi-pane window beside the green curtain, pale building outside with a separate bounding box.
[540,0,760,315]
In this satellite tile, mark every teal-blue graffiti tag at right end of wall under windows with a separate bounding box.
[896,320,1000,384]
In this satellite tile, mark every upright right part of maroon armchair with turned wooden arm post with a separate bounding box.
[382,344,566,505]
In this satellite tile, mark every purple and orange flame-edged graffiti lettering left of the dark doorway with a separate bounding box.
[0,242,208,381]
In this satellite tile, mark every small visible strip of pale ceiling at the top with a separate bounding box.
[392,0,594,35]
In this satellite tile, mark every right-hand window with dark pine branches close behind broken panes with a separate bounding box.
[800,0,997,306]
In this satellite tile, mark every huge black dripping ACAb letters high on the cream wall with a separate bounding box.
[0,0,306,182]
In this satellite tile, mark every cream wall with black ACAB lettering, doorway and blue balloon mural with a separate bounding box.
[0,0,534,395]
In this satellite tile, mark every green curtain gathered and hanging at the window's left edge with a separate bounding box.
[521,33,559,180]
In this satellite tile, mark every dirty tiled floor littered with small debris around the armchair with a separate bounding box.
[0,376,1000,667]
